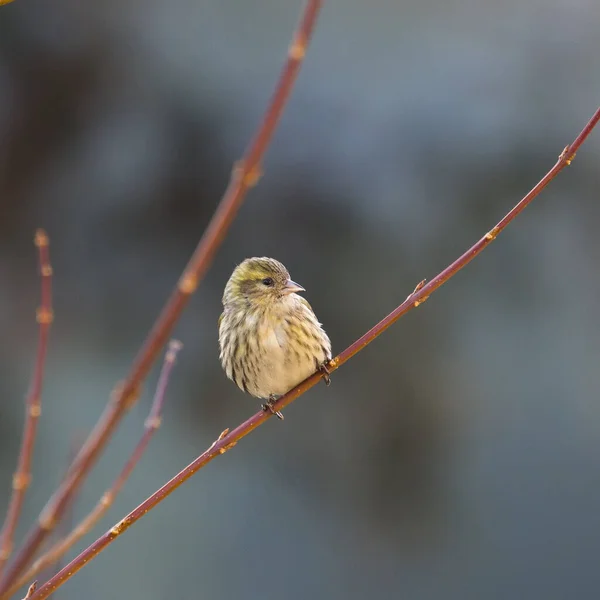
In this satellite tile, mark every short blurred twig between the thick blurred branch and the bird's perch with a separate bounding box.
[2,340,182,598]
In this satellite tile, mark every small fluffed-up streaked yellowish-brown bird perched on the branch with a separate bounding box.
[219,257,331,419]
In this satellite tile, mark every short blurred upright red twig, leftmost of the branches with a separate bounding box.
[0,229,53,574]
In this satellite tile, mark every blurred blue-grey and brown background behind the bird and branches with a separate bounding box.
[0,0,600,600]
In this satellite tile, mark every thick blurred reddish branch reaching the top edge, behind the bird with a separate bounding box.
[0,0,322,595]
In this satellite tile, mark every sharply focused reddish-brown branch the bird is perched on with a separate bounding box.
[23,108,600,600]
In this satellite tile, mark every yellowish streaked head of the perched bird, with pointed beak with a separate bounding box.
[223,257,304,308]
